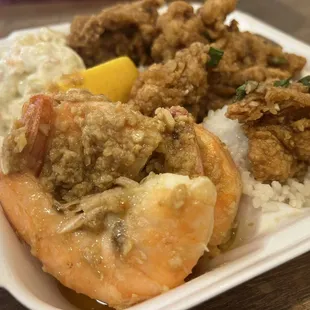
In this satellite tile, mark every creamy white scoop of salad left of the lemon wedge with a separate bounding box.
[0,28,85,135]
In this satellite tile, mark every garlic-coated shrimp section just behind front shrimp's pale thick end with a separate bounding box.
[147,106,204,177]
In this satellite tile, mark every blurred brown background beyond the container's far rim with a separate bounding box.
[0,0,310,43]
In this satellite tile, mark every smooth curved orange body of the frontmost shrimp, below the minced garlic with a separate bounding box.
[0,173,216,309]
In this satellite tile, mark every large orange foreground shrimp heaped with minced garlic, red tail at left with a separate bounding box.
[0,91,217,308]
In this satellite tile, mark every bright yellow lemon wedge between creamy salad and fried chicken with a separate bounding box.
[57,57,139,102]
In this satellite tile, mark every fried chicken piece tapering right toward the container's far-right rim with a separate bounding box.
[209,29,306,98]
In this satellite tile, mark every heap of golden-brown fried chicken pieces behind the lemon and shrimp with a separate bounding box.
[68,0,306,116]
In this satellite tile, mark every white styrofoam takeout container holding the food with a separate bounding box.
[0,6,310,310]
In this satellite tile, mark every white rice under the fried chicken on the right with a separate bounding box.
[203,107,310,212]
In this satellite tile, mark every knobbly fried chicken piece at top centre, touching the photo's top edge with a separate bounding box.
[152,0,236,62]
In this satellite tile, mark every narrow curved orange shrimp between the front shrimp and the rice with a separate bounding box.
[195,125,242,252]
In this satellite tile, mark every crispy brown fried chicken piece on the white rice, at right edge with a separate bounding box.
[227,81,310,182]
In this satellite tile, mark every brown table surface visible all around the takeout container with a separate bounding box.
[0,0,310,310]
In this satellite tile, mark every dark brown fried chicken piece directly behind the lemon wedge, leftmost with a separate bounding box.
[68,0,163,67]
